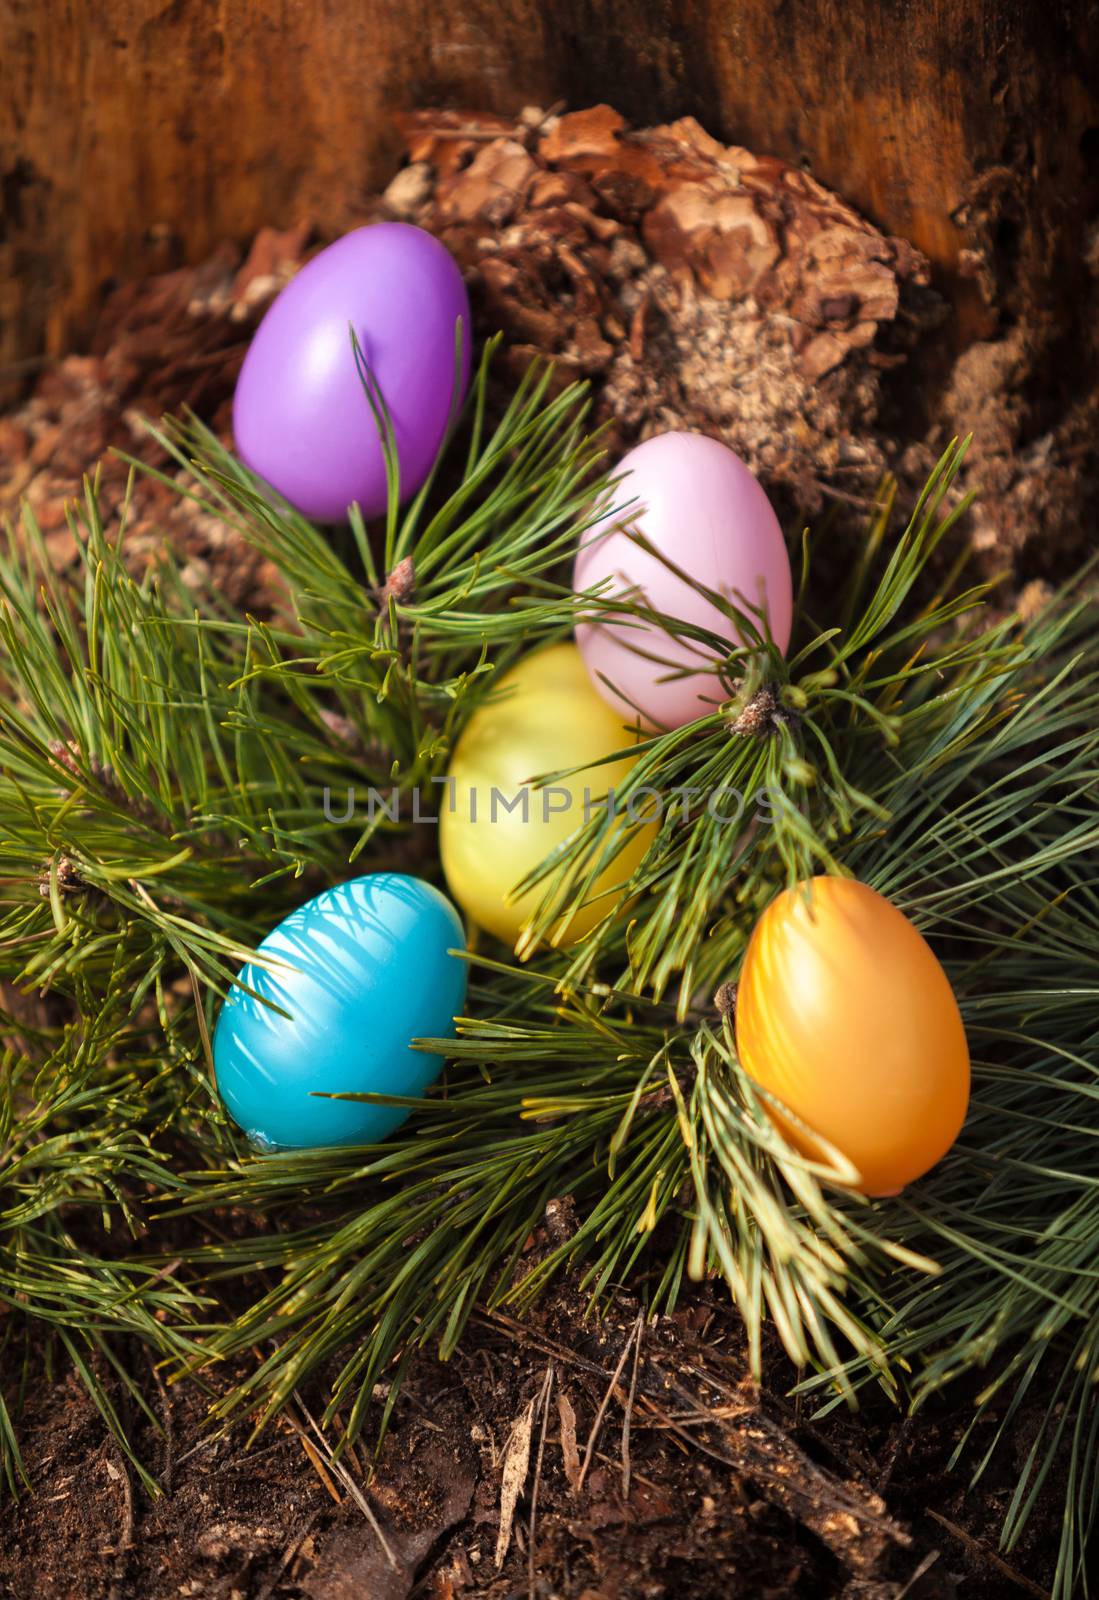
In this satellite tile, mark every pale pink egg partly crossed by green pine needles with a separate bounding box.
[573,434,793,728]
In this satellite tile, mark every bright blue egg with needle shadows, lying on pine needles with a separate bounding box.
[214,872,467,1150]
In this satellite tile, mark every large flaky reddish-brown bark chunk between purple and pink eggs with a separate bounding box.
[402,106,928,512]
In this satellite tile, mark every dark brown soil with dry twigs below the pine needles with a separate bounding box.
[0,1285,1059,1600]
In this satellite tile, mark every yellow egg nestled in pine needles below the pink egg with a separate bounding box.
[438,645,654,947]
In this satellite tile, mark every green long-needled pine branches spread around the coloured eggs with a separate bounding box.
[0,355,1099,1600]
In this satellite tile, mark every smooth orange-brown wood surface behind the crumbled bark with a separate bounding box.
[0,0,1099,381]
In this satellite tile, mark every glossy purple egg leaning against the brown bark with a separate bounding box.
[234,222,470,522]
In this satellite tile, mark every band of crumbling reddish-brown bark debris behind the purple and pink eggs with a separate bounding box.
[0,90,1099,592]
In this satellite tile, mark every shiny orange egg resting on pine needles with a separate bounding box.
[736,877,969,1195]
